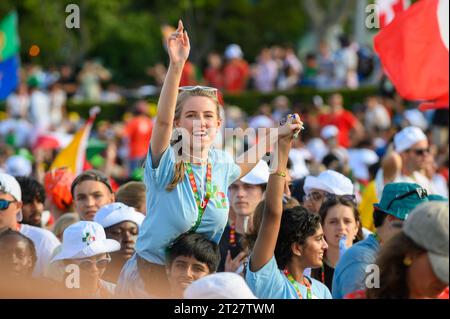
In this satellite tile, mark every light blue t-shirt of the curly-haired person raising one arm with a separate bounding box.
[245,256,332,299]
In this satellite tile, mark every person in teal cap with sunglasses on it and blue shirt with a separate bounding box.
[332,183,429,299]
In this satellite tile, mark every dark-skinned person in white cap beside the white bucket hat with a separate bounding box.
[94,202,145,283]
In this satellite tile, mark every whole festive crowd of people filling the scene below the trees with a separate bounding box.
[0,21,449,299]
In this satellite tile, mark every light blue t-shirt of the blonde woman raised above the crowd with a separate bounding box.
[136,147,241,265]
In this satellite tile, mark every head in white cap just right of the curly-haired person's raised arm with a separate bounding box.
[303,170,356,214]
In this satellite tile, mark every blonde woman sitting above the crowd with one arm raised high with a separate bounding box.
[119,20,302,297]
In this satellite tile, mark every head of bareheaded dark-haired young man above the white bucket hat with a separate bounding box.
[70,169,115,221]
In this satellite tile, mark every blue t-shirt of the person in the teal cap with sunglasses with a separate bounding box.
[332,235,380,299]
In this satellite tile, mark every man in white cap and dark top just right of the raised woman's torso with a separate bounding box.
[218,160,269,272]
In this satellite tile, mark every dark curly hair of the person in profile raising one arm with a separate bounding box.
[275,206,320,269]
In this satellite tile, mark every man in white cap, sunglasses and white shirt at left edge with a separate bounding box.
[0,173,60,277]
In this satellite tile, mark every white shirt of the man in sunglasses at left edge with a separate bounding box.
[20,224,61,277]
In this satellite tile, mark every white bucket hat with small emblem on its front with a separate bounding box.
[52,221,120,262]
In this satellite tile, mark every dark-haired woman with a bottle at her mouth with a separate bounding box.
[311,196,364,291]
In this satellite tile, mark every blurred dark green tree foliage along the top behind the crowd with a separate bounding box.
[0,0,314,82]
